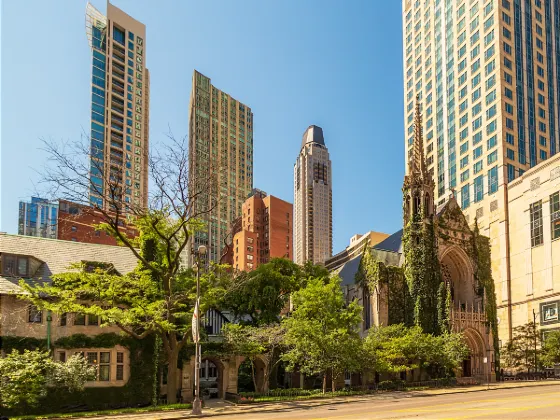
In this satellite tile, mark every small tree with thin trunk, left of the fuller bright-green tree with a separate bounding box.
[223,324,286,392]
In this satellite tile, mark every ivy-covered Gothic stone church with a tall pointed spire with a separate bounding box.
[336,101,497,380]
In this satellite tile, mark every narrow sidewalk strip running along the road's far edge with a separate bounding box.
[44,380,560,420]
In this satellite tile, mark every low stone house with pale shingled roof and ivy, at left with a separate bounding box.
[0,233,252,405]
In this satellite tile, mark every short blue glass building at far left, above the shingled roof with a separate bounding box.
[18,197,58,239]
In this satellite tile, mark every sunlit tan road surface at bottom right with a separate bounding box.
[217,384,560,420]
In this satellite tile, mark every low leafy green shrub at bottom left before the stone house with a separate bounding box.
[0,350,95,408]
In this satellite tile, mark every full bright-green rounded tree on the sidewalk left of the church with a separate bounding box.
[282,277,362,392]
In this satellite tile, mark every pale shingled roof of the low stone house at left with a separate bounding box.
[0,233,138,294]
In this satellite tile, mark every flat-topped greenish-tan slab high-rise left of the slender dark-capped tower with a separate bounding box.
[188,71,253,262]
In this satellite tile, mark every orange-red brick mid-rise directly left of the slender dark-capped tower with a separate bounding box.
[232,189,293,271]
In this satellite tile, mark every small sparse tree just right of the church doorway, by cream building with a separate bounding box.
[501,322,540,370]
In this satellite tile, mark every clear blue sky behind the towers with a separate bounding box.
[0,0,404,252]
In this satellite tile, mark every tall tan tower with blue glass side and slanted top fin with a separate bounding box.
[86,2,150,208]
